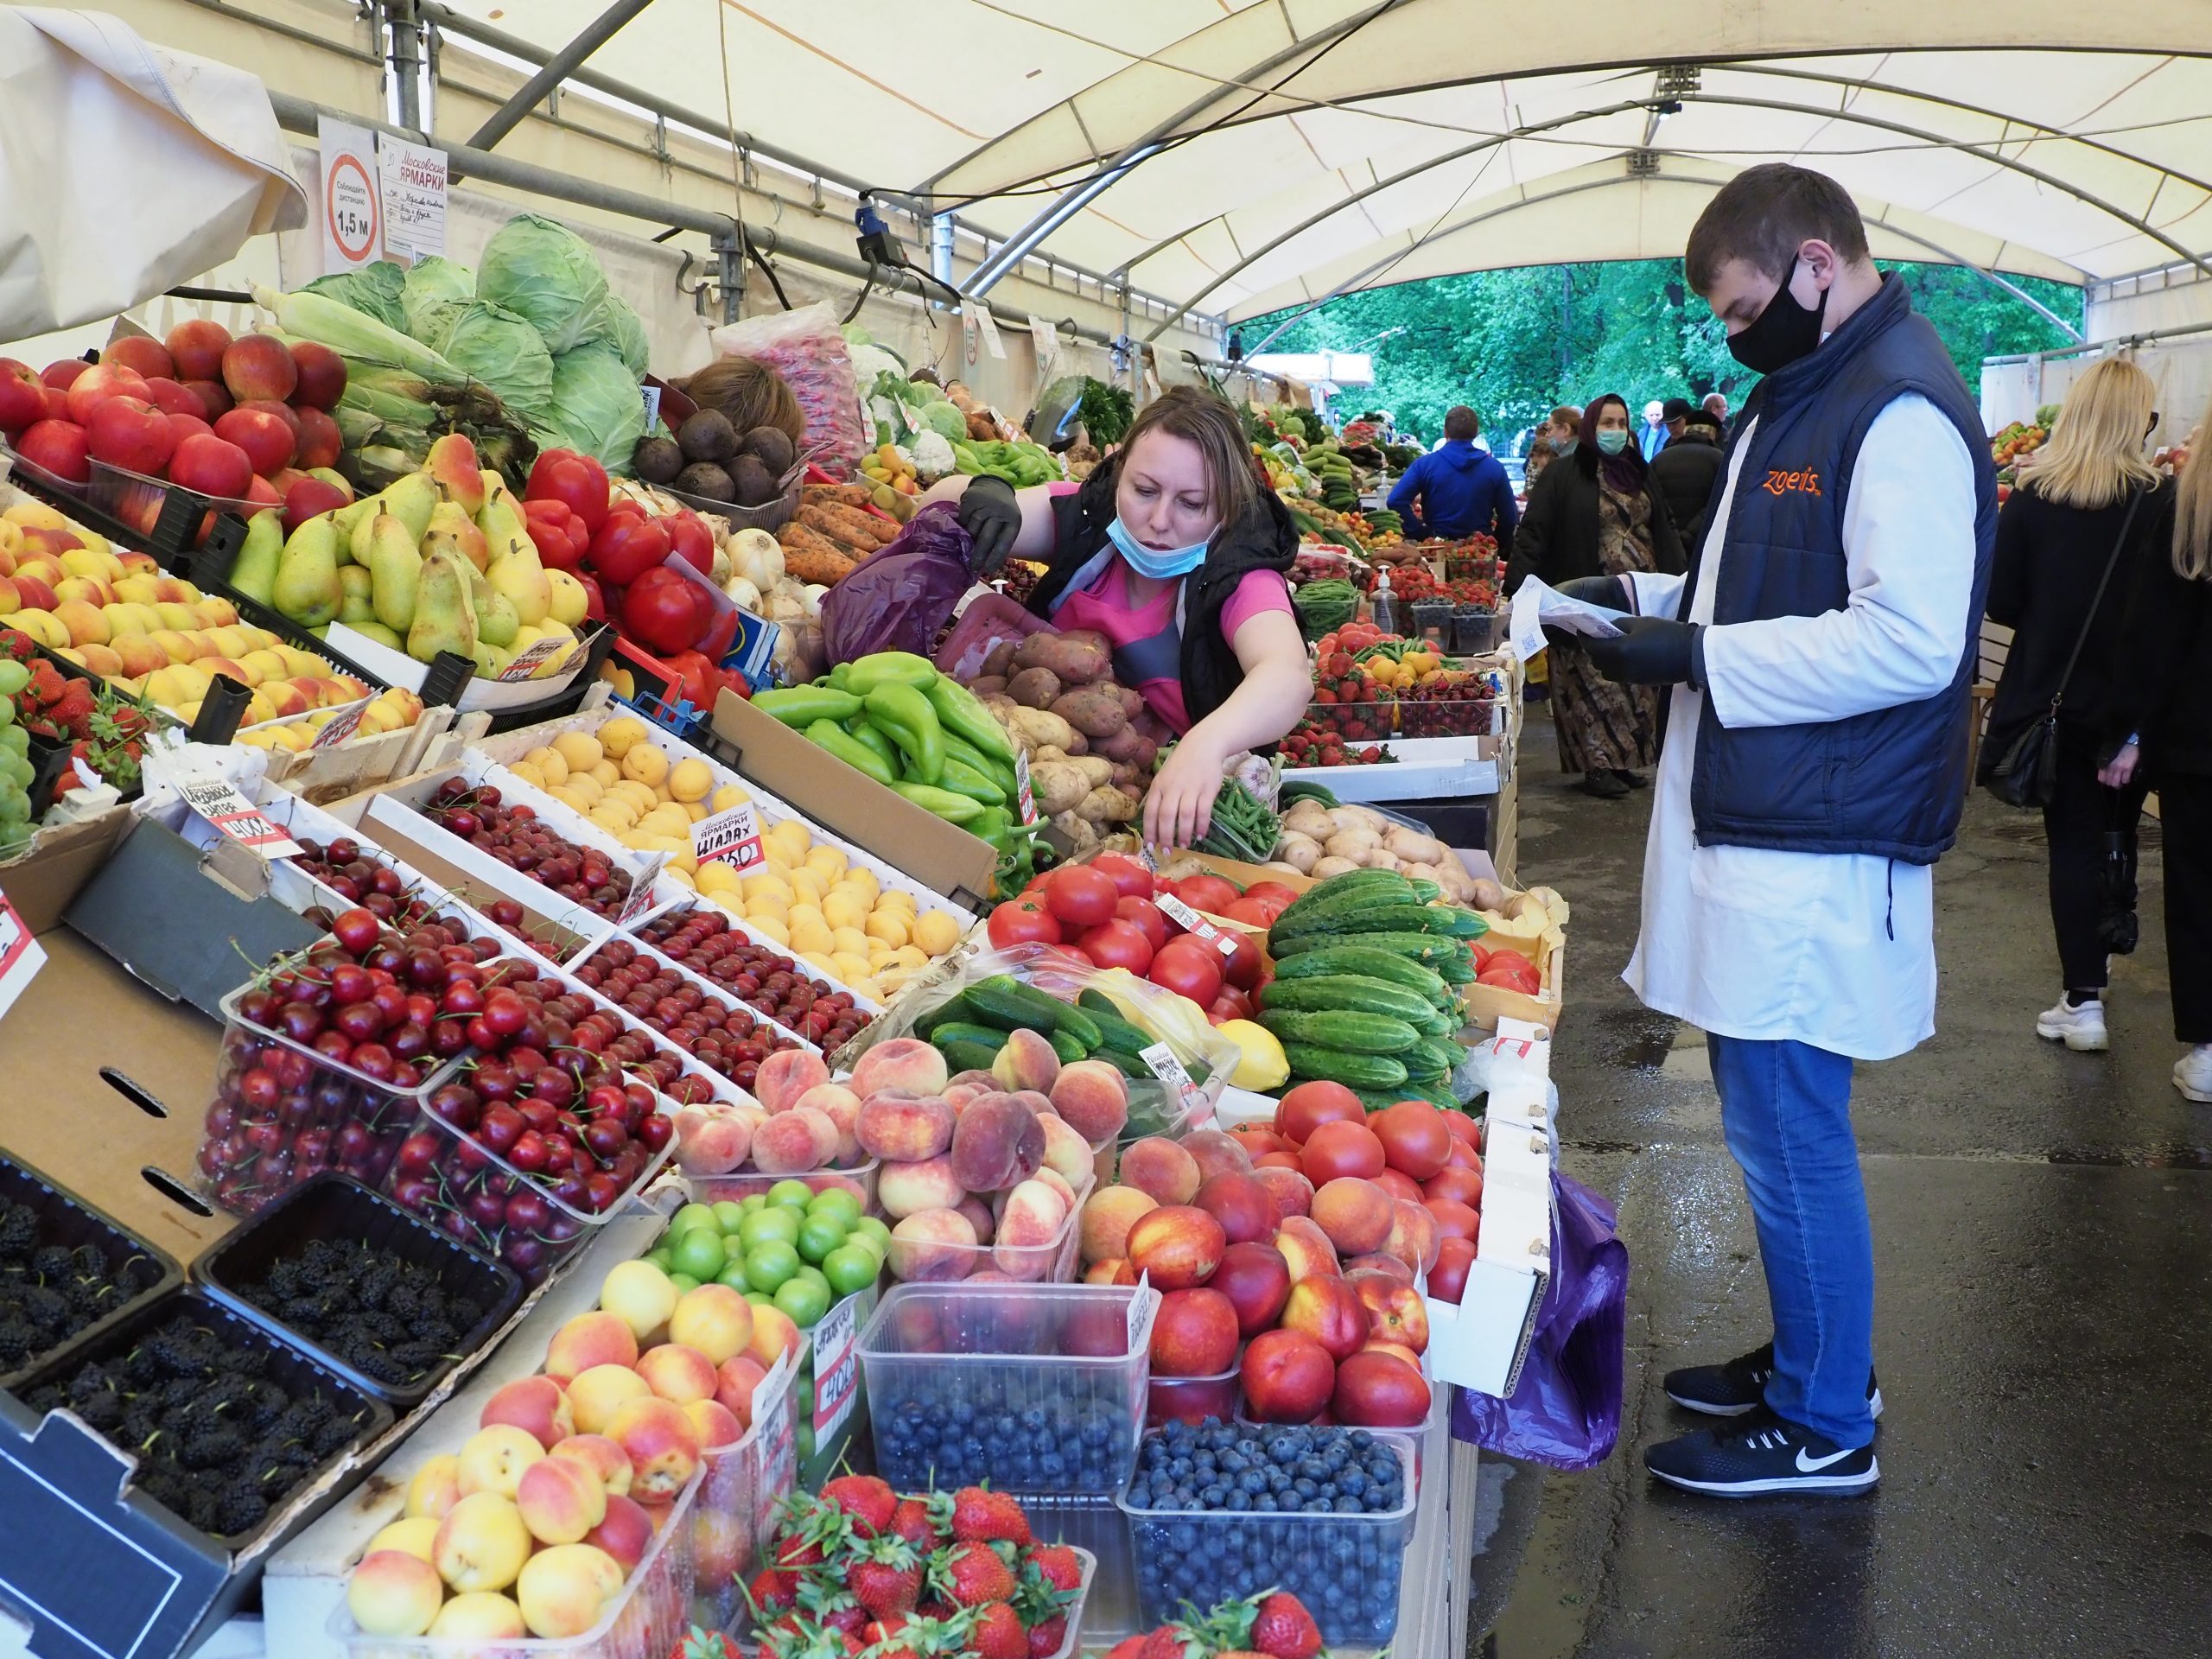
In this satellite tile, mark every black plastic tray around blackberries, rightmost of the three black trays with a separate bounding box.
[193,1173,522,1415]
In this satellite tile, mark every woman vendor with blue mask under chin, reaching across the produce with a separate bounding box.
[927,387,1314,847]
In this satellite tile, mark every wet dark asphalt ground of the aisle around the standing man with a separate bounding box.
[1469,712,2212,1659]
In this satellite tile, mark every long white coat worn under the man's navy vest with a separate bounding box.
[1621,396,1975,1059]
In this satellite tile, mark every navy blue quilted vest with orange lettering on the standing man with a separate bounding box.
[1681,276,1998,865]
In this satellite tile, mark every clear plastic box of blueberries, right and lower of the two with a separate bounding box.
[1117,1429,1414,1648]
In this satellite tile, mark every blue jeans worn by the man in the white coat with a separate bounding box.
[1707,1035,1873,1446]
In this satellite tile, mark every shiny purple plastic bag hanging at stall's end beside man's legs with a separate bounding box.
[1451,1170,1628,1469]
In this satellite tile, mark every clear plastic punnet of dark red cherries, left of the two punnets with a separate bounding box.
[199,987,460,1217]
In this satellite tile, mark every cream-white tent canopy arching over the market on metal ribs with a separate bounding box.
[435,0,2212,332]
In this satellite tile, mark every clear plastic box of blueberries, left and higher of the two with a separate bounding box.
[861,1283,1159,1497]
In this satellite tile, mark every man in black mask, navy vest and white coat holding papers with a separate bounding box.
[1571,163,1998,1497]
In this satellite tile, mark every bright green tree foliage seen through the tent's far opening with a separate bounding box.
[1241,259,2082,449]
